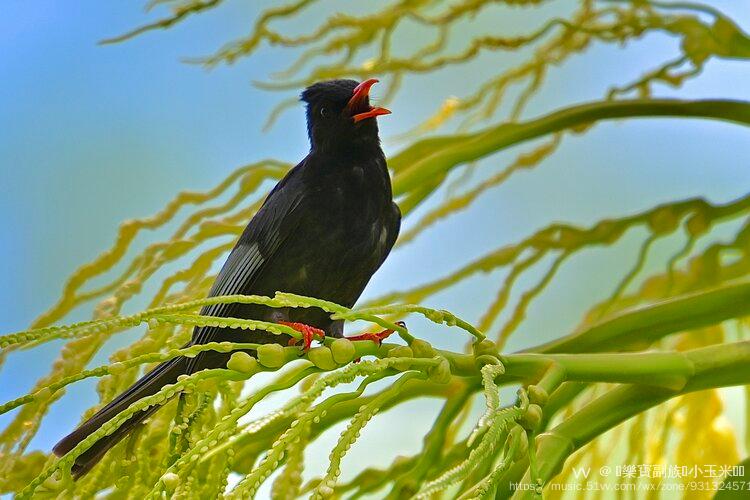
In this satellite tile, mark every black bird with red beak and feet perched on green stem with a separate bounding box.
[54,79,401,477]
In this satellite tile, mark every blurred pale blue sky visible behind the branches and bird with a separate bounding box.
[0,0,750,492]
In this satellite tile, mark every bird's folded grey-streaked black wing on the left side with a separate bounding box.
[187,162,305,374]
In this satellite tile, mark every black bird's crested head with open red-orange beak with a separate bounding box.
[301,78,390,150]
